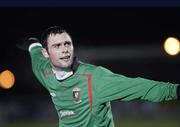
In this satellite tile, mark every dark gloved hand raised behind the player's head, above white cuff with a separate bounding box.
[16,37,40,51]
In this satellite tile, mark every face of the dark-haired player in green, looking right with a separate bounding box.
[47,33,74,70]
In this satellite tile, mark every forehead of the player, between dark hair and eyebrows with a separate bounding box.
[47,32,72,44]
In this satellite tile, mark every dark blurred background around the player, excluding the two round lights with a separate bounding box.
[0,7,180,127]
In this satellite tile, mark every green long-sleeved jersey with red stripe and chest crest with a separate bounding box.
[30,45,178,127]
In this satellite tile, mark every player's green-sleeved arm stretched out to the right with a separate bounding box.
[95,67,180,102]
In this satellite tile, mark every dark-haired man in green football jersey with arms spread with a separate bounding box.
[16,26,180,127]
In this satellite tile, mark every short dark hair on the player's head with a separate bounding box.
[41,26,67,49]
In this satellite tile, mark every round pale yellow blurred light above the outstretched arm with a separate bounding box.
[164,37,180,55]
